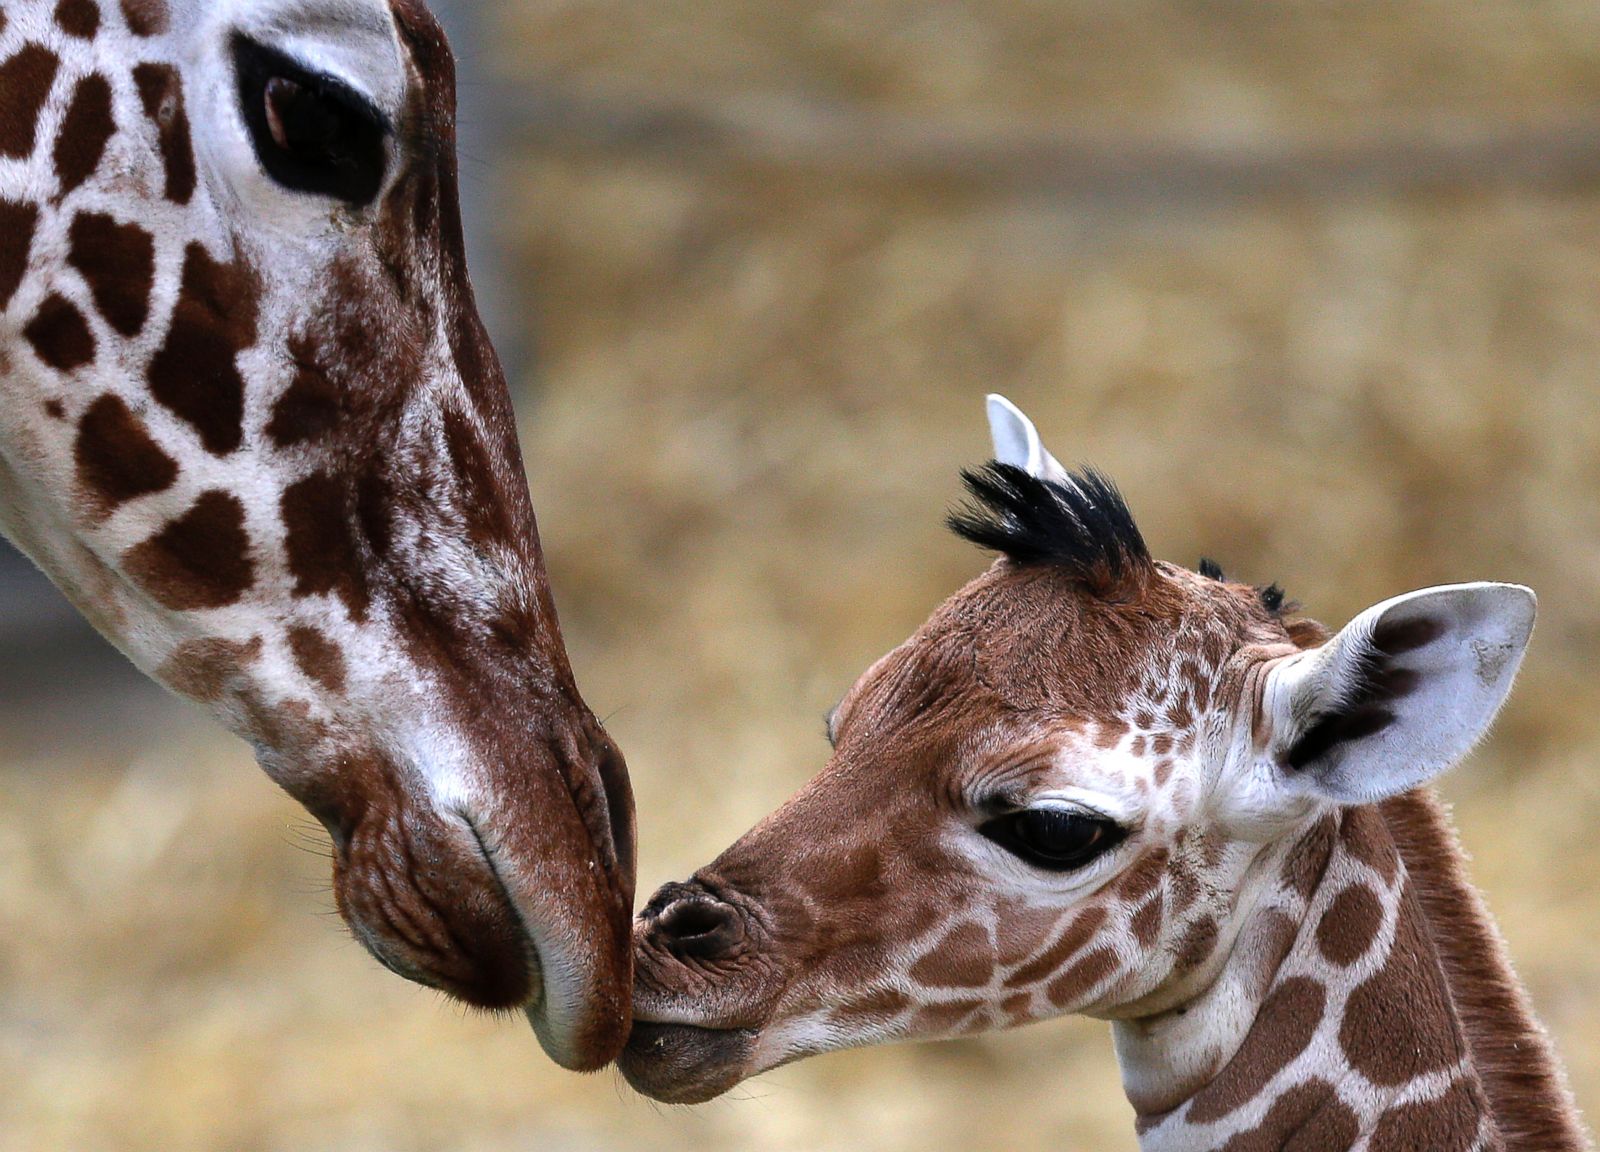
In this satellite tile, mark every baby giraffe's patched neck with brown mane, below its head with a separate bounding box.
[1117,790,1589,1152]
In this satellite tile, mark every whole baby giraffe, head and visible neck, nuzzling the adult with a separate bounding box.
[622,397,1587,1152]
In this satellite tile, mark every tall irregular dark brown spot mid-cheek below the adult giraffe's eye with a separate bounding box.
[149,243,256,456]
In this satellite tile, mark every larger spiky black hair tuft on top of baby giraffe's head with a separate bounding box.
[949,461,1152,592]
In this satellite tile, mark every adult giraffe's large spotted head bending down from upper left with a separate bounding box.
[0,0,634,1067]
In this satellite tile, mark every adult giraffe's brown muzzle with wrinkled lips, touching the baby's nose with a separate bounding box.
[304,720,634,1070]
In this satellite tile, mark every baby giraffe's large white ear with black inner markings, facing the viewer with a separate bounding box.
[1261,584,1536,803]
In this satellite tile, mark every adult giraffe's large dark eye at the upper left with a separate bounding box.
[234,35,389,208]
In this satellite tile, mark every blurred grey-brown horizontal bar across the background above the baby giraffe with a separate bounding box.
[494,83,1600,206]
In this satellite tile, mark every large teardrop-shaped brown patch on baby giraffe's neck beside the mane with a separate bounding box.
[1339,888,1462,1085]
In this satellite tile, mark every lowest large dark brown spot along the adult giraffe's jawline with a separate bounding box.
[123,491,256,611]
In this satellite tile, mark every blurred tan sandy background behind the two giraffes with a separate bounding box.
[0,0,1600,1152]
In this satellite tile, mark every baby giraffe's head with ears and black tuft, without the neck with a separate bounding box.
[622,397,1534,1102]
